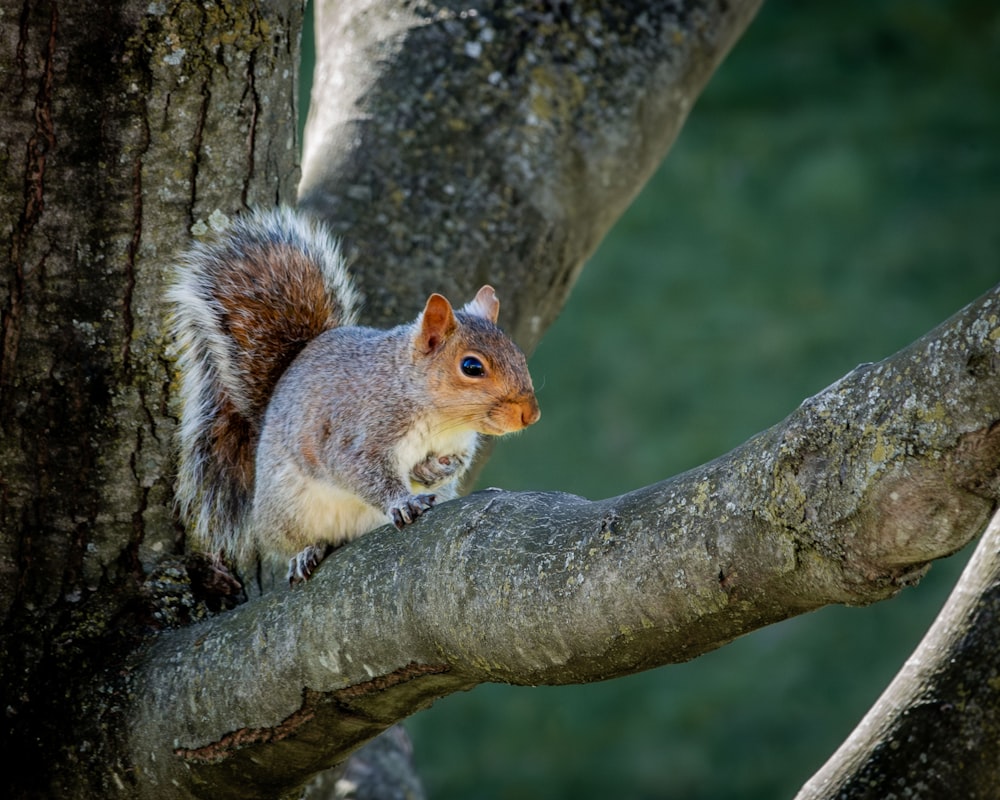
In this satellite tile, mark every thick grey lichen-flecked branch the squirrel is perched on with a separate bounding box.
[125,286,1000,797]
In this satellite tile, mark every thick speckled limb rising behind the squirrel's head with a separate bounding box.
[299,0,761,352]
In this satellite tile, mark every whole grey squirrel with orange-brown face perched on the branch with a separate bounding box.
[169,208,540,583]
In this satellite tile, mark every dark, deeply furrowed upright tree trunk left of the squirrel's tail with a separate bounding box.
[0,0,301,797]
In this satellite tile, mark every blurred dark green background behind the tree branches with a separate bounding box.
[304,0,1000,800]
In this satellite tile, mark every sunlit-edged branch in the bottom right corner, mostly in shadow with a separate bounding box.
[796,514,1000,800]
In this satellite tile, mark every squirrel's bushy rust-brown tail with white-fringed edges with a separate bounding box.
[169,209,358,562]
